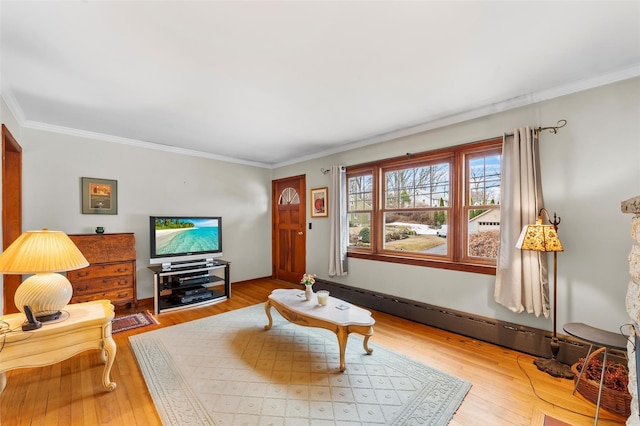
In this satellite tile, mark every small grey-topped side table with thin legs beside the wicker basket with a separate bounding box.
[562,322,627,425]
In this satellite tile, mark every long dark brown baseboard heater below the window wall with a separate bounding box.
[313,279,626,365]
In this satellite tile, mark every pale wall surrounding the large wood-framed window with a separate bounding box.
[273,78,640,332]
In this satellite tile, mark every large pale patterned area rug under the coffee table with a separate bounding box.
[129,304,471,426]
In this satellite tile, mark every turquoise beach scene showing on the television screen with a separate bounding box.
[156,219,220,255]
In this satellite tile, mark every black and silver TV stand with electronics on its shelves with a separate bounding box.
[148,259,231,314]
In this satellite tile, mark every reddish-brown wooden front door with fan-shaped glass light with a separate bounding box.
[271,175,307,283]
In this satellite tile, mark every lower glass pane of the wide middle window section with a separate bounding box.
[384,210,447,255]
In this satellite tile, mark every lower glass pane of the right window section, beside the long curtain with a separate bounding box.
[467,205,500,259]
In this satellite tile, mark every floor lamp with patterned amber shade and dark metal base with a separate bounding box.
[516,208,573,379]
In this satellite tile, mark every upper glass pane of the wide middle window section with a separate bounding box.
[384,163,450,209]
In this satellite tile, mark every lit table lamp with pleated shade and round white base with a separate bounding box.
[0,229,89,321]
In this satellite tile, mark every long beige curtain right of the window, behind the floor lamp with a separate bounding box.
[494,127,549,317]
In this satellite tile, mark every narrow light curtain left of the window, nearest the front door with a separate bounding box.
[329,166,349,277]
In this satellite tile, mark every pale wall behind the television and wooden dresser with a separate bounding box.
[19,128,271,298]
